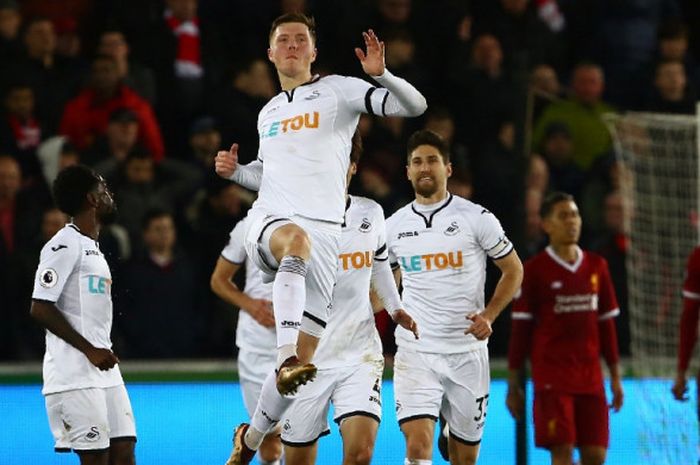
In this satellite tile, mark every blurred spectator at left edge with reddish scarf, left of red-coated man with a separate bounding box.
[0,82,42,178]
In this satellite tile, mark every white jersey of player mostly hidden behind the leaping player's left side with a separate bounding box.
[221,219,277,354]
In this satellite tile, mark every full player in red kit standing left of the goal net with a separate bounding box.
[506,192,623,465]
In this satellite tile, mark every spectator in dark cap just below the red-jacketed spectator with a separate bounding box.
[81,107,139,167]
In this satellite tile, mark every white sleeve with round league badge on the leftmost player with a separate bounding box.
[32,234,81,303]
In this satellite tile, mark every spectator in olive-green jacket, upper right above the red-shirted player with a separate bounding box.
[533,62,613,170]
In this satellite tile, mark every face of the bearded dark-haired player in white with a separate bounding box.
[406,145,452,197]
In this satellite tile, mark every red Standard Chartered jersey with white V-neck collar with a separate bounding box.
[512,247,620,394]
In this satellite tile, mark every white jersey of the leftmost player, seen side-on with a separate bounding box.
[32,224,124,394]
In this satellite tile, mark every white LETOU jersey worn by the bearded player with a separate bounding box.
[386,194,513,353]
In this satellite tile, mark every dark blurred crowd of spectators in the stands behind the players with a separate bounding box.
[0,0,700,360]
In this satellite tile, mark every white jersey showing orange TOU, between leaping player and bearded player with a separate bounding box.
[314,196,389,368]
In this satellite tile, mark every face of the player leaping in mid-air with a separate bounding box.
[267,23,316,77]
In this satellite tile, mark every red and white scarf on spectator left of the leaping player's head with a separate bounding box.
[165,10,204,79]
